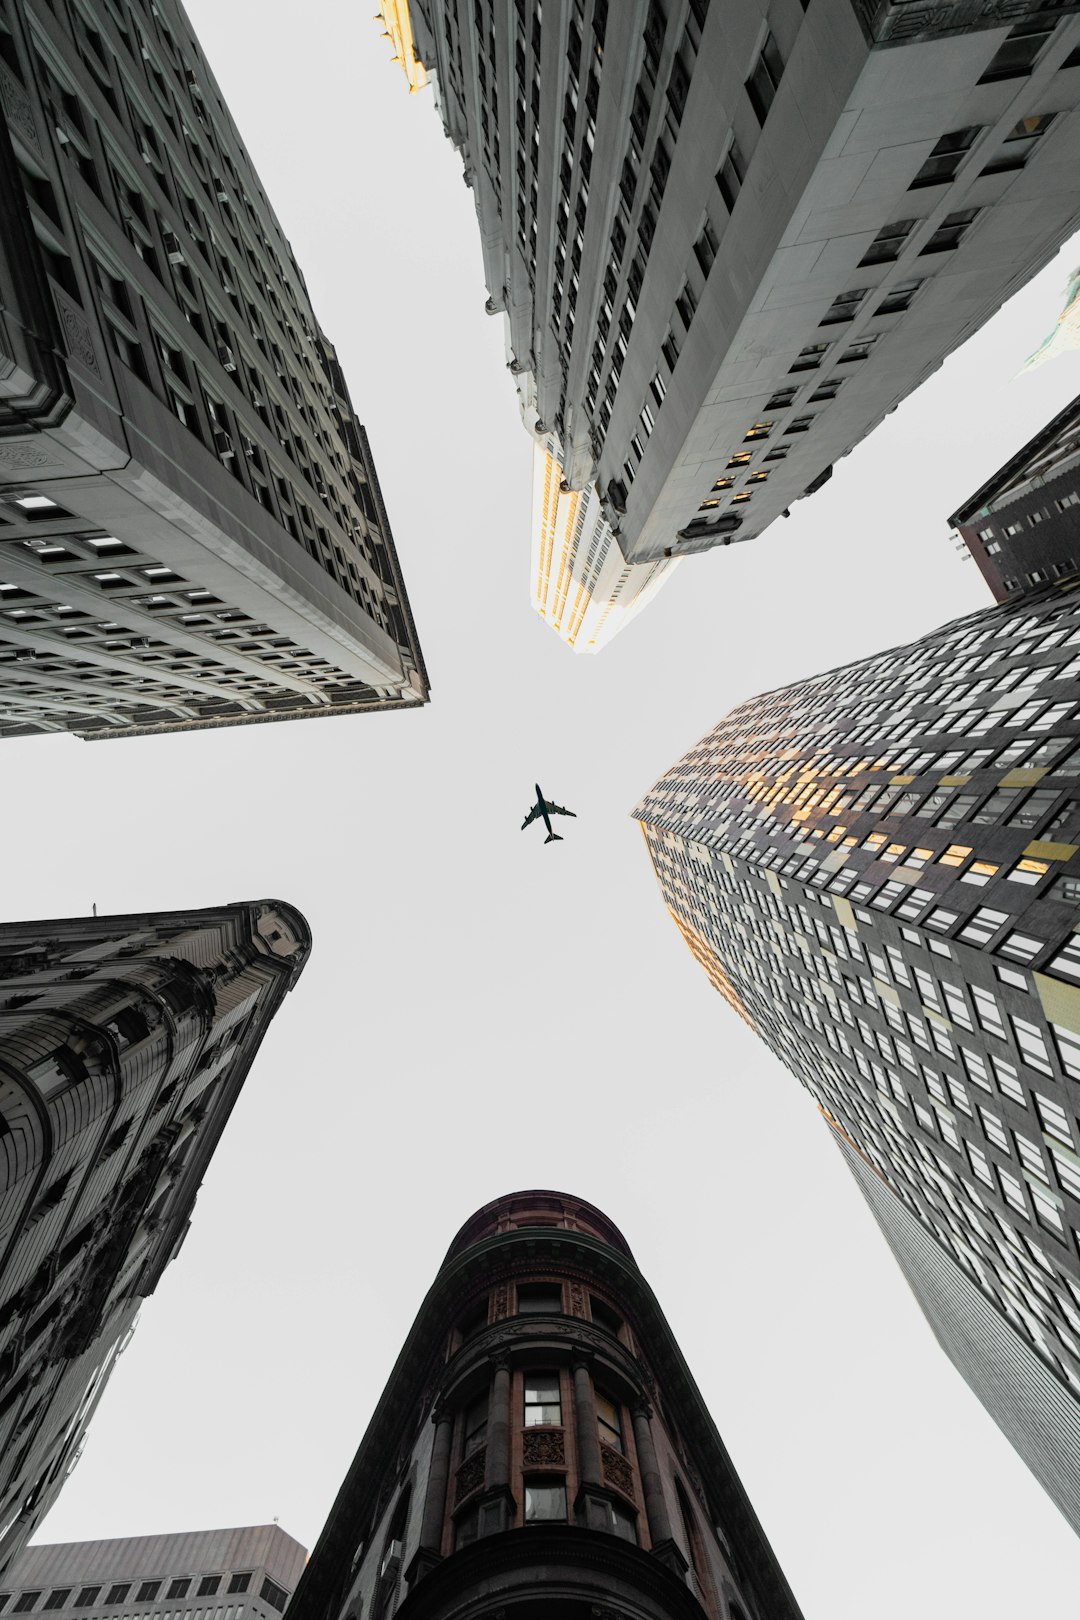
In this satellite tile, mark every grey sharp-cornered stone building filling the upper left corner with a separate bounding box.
[0,0,427,739]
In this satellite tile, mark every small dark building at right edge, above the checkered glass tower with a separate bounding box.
[949,387,1080,603]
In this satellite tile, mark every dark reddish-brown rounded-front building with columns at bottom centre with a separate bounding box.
[290,1192,800,1620]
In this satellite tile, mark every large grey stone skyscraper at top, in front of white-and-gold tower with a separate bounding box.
[382,0,1080,645]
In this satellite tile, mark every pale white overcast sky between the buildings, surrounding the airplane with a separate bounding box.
[19,0,1080,1620]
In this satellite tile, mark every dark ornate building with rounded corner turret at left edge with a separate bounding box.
[0,901,311,1584]
